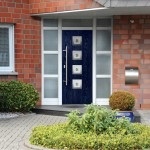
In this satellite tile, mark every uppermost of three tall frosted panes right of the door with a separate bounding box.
[96,30,111,51]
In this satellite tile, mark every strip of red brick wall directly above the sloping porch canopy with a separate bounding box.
[29,0,100,14]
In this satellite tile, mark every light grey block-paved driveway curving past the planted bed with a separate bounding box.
[0,114,66,150]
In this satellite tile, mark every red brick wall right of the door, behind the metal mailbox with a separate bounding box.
[113,15,150,109]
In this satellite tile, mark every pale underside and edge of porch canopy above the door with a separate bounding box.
[32,6,150,18]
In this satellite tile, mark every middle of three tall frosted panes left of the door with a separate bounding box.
[44,54,58,74]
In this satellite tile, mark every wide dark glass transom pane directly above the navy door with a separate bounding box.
[62,19,93,27]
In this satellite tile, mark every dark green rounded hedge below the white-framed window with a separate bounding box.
[0,81,39,112]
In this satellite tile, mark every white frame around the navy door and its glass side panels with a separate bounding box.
[41,17,113,105]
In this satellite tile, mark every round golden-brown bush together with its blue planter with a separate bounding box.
[109,91,135,122]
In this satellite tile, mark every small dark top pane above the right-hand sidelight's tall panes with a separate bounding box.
[96,18,111,27]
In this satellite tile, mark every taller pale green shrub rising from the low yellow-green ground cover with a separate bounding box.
[67,105,137,134]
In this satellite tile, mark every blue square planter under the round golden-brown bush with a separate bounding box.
[116,111,134,122]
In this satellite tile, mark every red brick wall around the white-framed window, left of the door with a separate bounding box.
[0,0,41,103]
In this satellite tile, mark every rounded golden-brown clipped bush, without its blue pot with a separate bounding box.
[109,91,135,110]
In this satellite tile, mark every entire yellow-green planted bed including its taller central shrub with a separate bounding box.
[30,105,150,150]
